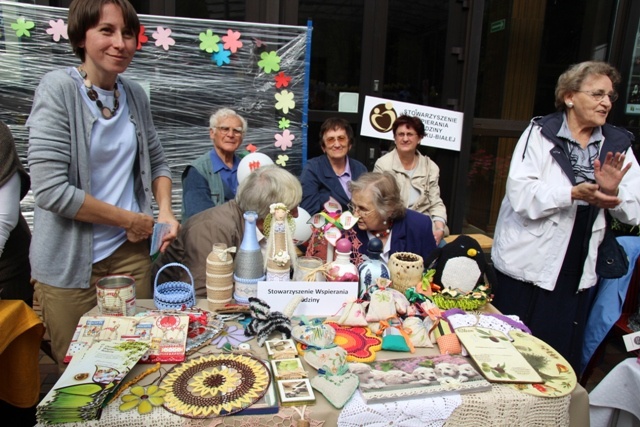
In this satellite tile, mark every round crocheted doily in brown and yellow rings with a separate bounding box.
[160,354,271,418]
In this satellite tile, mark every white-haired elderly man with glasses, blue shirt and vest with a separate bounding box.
[182,108,247,222]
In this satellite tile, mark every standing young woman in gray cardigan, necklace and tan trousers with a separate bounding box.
[27,0,179,367]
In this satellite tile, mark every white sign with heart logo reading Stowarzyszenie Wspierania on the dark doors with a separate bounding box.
[360,96,464,151]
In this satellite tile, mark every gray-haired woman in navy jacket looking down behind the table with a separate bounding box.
[349,172,436,262]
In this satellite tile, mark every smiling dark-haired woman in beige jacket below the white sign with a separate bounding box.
[373,115,449,245]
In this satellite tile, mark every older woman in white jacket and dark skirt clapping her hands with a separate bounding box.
[491,61,640,370]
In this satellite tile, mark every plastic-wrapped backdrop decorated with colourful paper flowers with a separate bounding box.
[0,1,311,224]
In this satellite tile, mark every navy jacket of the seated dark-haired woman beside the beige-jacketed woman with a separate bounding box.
[300,154,367,215]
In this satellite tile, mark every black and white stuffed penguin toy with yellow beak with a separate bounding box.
[424,234,496,292]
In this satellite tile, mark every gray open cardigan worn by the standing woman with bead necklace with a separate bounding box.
[27,67,171,288]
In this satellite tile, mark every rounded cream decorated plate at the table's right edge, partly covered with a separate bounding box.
[508,330,578,397]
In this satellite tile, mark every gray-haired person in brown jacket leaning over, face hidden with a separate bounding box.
[152,166,302,296]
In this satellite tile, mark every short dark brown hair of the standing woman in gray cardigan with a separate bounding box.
[67,0,140,62]
